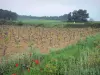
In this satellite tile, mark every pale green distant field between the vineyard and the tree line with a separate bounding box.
[18,19,86,27]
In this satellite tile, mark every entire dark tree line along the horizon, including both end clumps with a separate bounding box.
[0,9,89,22]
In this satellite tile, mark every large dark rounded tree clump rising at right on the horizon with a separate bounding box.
[67,9,89,22]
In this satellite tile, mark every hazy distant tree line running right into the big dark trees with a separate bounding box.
[19,9,89,22]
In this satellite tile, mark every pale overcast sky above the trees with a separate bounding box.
[0,0,100,21]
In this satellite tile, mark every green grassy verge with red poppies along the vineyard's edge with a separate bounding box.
[0,34,100,75]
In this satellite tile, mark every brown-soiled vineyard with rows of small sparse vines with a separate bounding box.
[0,26,100,56]
